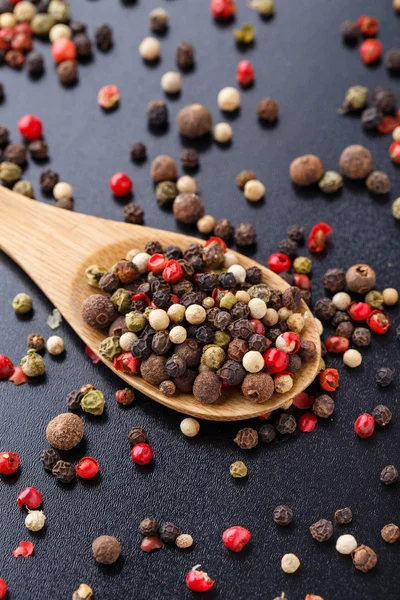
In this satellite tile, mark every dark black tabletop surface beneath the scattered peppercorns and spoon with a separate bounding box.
[0,0,400,600]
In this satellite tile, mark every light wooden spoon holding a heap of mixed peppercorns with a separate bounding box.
[0,187,320,421]
